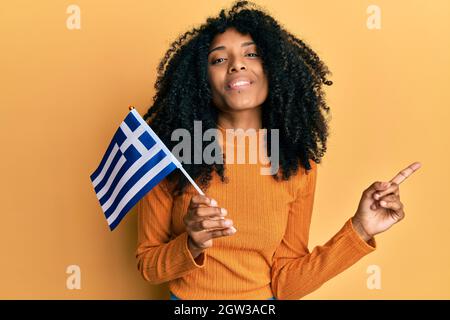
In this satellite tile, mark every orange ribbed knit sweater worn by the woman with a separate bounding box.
[136,128,376,299]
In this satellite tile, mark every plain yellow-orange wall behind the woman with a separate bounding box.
[0,0,450,299]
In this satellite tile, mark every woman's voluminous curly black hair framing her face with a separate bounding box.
[144,1,332,194]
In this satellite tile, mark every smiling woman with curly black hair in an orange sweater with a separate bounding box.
[136,1,420,299]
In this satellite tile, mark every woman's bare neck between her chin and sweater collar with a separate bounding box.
[217,107,262,130]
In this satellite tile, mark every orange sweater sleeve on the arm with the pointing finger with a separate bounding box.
[271,161,376,300]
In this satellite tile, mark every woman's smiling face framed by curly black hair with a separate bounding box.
[208,28,268,112]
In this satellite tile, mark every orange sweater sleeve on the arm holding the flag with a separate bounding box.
[136,180,206,284]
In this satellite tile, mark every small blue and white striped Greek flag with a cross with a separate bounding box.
[91,109,181,230]
